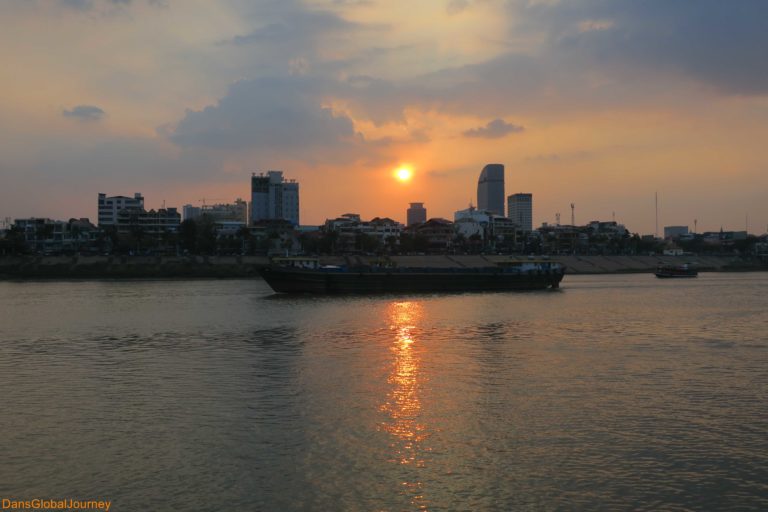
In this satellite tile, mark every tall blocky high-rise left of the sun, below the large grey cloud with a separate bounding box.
[251,171,299,226]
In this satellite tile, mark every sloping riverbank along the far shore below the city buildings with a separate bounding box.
[0,255,768,279]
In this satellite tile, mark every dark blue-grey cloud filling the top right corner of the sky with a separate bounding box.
[511,0,768,94]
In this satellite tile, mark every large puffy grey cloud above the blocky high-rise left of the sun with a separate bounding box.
[170,76,362,156]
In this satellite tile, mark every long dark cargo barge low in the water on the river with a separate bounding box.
[261,258,564,294]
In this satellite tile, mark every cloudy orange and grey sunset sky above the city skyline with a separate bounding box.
[0,0,768,234]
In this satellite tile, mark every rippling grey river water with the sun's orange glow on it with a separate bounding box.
[0,274,768,511]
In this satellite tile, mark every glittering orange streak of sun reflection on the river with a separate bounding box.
[380,302,429,510]
